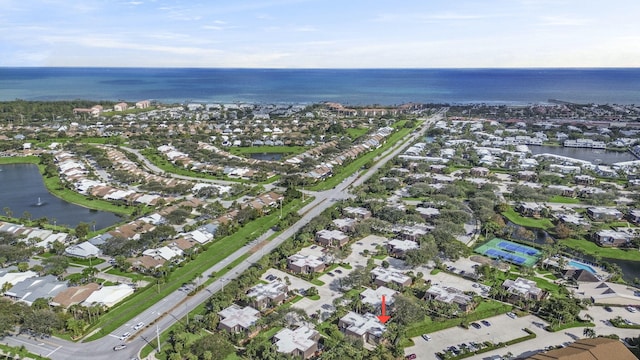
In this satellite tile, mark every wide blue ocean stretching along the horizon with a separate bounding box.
[0,68,640,105]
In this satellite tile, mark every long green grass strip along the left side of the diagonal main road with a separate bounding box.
[86,200,300,341]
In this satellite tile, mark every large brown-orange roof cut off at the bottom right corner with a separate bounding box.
[526,337,637,360]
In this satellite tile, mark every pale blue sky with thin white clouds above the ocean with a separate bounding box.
[0,0,640,68]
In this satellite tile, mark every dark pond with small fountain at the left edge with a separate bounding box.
[0,164,121,229]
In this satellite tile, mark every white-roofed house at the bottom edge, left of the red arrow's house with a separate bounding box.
[273,326,320,359]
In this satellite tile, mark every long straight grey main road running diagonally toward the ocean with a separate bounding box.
[2,114,441,360]
